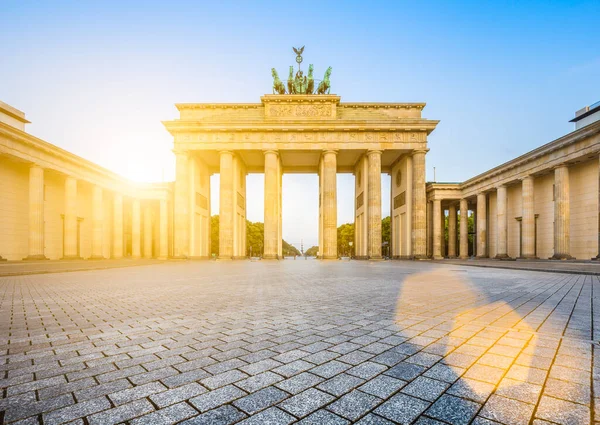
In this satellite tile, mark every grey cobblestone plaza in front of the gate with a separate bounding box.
[0,260,600,425]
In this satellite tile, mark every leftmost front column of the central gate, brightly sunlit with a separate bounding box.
[173,151,189,258]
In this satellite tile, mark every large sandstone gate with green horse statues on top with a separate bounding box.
[164,55,438,259]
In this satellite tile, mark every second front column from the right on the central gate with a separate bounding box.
[368,150,382,260]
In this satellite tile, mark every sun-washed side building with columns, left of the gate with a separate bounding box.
[0,102,173,260]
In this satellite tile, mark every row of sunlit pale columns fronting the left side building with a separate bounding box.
[25,164,168,260]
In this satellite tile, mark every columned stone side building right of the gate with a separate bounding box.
[427,102,600,260]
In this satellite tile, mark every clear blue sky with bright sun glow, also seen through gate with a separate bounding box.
[0,0,600,245]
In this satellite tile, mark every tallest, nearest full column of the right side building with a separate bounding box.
[552,164,573,260]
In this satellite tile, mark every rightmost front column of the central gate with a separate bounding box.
[412,149,427,260]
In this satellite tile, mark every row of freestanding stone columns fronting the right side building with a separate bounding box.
[430,164,573,260]
